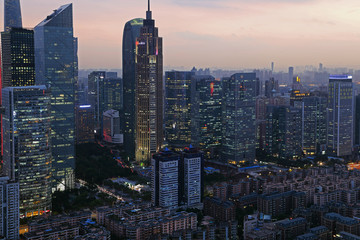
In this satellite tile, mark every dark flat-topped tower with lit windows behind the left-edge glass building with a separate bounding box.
[1,28,35,87]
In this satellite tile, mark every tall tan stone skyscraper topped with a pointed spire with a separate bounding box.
[135,1,164,162]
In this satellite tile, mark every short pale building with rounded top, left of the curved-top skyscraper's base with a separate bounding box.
[102,109,124,144]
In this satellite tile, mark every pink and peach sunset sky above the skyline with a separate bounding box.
[1,0,360,69]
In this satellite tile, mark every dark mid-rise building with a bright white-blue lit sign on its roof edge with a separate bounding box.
[75,105,95,144]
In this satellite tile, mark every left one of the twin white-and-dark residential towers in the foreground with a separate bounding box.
[151,149,180,208]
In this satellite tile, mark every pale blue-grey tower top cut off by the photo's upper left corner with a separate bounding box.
[4,0,22,31]
